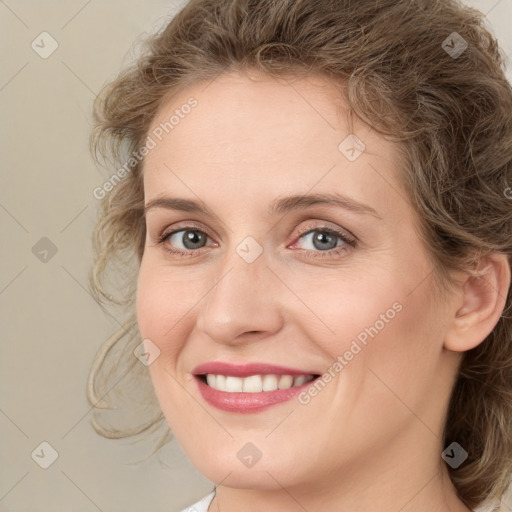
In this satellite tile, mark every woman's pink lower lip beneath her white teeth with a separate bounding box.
[195,376,315,414]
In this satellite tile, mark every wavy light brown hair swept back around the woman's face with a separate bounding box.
[88,0,512,508]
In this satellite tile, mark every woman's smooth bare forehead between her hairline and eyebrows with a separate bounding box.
[144,73,405,220]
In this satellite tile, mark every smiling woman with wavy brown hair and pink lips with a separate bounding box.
[89,0,512,512]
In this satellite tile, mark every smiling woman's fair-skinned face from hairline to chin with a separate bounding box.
[137,74,459,492]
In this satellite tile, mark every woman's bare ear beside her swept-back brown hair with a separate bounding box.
[444,253,511,352]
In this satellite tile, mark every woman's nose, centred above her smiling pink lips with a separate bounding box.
[197,243,286,345]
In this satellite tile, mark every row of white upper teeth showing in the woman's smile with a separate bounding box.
[206,373,313,393]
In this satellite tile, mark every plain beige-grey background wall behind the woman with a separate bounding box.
[0,0,512,512]
